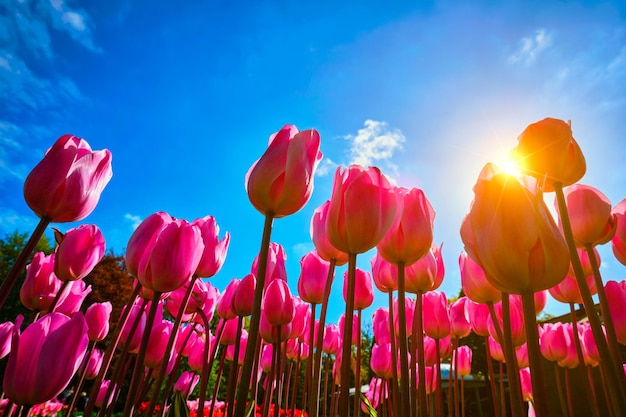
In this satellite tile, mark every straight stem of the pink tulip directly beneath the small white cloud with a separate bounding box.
[339,253,356,416]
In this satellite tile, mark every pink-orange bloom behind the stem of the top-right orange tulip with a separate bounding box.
[555,184,617,248]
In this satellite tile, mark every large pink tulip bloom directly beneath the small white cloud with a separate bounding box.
[326,165,396,255]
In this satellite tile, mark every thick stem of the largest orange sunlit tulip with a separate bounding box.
[521,291,550,416]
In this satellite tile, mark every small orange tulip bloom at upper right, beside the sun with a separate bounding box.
[512,118,587,192]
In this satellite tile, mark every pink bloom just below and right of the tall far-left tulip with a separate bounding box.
[54,224,106,281]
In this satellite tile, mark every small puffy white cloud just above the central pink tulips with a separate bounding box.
[345,119,406,177]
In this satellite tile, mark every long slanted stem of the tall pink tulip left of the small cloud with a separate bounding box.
[235,213,274,417]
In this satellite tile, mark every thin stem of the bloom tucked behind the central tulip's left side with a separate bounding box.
[309,259,337,417]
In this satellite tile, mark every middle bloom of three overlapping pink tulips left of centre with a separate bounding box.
[138,220,204,293]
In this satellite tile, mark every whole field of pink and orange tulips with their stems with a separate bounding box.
[0,118,626,417]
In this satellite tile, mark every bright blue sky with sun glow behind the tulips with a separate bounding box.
[0,0,626,320]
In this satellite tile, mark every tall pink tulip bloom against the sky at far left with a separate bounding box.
[24,135,113,223]
